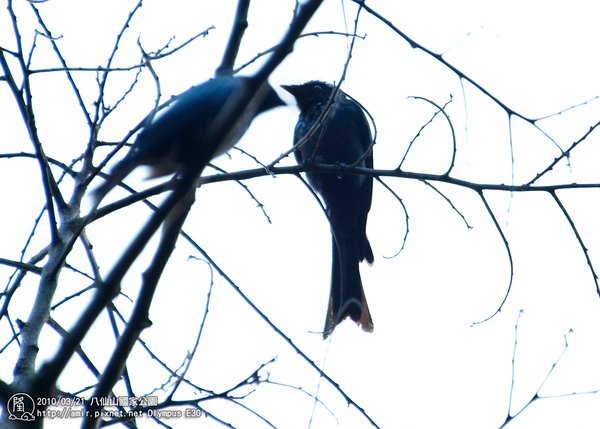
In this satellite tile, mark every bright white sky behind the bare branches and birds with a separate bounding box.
[0,0,600,428]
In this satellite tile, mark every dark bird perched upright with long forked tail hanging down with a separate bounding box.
[282,81,373,338]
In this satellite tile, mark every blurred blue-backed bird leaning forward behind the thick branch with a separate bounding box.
[95,76,285,204]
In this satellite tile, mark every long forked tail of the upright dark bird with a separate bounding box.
[323,237,373,339]
